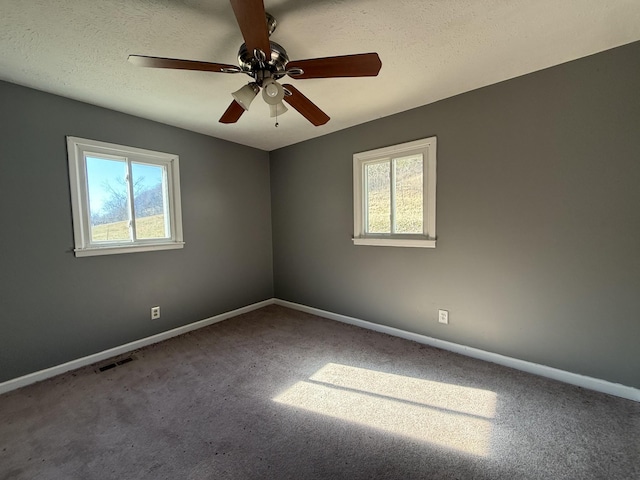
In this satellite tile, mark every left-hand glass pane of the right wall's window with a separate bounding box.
[364,162,391,233]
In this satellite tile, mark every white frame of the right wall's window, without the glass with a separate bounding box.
[353,137,437,248]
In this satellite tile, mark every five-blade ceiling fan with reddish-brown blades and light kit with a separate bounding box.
[129,0,382,126]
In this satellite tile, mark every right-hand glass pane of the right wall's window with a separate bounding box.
[393,154,424,234]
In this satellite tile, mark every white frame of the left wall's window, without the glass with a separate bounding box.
[67,136,184,257]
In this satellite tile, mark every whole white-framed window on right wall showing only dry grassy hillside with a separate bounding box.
[353,137,436,248]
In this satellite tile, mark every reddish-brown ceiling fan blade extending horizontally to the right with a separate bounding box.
[286,53,382,79]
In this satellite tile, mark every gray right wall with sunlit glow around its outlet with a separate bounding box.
[270,43,640,388]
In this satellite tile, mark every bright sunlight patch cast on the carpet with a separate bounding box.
[274,363,496,456]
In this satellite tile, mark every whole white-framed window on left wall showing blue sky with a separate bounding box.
[67,137,184,257]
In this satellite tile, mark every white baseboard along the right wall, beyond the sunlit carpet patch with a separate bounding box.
[274,299,640,402]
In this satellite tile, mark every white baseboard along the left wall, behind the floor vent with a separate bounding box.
[0,298,275,395]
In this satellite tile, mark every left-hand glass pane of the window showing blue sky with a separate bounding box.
[86,156,131,242]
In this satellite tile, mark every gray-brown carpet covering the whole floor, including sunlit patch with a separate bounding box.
[0,306,640,480]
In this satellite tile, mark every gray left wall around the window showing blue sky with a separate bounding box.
[0,82,273,382]
